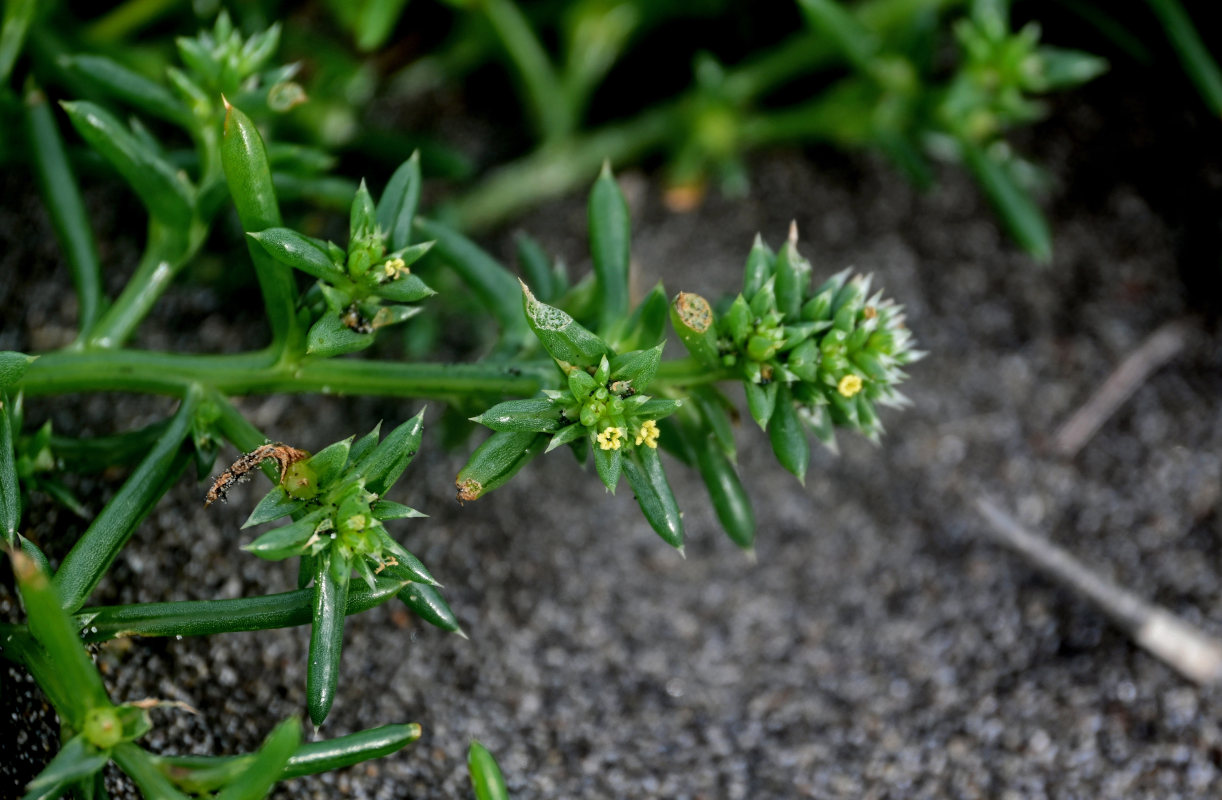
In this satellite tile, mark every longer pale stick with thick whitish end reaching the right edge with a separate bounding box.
[976,497,1222,684]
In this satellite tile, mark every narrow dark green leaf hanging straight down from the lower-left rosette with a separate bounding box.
[306,550,352,727]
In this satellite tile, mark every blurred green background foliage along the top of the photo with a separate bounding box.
[0,0,1222,261]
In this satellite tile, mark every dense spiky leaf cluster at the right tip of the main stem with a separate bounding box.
[671,228,924,488]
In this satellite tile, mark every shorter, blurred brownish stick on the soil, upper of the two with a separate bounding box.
[1052,320,1190,458]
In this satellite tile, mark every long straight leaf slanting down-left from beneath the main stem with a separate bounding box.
[55,388,199,611]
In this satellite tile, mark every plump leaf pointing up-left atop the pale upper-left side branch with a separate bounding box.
[62,100,196,228]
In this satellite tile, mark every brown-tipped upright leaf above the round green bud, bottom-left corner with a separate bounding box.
[12,552,110,730]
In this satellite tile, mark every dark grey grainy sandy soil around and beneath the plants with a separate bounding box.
[0,15,1222,799]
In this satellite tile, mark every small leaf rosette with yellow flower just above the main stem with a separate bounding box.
[249,155,435,355]
